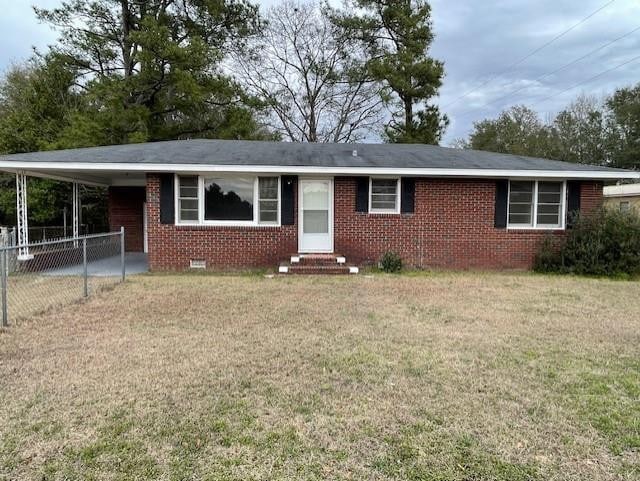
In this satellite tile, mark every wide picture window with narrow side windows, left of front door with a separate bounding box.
[176,175,280,226]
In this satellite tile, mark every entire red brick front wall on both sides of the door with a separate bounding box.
[142,174,602,270]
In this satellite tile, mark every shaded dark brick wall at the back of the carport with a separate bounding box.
[109,187,146,252]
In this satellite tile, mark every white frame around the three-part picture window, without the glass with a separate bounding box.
[174,172,282,227]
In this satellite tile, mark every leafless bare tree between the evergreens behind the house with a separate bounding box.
[233,0,383,142]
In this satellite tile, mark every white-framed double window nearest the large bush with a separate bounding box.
[509,180,565,229]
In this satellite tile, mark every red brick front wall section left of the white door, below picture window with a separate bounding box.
[147,174,298,270]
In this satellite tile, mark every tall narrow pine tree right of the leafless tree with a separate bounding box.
[333,0,449,144]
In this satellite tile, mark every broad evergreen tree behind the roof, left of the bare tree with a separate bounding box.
[36,0,270,142]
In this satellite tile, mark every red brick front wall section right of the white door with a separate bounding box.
[335,177,602,269]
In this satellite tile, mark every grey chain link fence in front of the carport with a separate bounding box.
[0,230,125,326]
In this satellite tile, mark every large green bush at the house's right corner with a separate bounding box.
[534,210,640,276]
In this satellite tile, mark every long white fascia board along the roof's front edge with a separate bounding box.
[0,161,640,180]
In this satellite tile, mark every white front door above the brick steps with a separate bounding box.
[298,179,333,252]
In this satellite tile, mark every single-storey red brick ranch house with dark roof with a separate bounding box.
[0,140,640,272]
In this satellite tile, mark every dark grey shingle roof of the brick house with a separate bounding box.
[0,140,625,172]
